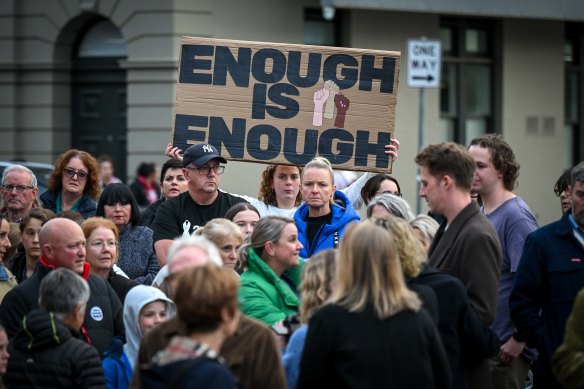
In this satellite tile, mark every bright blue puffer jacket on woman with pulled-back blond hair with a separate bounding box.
[294,190,360,258]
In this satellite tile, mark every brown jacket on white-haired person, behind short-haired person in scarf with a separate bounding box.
[130,316,286,389]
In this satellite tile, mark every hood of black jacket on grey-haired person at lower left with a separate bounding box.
[13,310,71,353]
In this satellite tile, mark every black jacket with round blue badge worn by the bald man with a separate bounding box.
[0,257,125,355]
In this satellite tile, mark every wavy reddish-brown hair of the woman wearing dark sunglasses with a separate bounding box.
[47,149,101,200]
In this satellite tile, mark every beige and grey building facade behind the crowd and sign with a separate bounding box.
[0,0,584,224]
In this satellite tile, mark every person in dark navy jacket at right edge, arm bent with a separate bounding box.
[509,162,584,389]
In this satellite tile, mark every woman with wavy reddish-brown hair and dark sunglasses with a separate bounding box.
[41,149,100,218]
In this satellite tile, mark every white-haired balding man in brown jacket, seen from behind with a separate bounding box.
[130,233,286,389]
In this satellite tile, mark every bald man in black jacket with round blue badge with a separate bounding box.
[0,218,124,355]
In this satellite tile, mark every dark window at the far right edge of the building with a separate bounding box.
[563,23,584,164]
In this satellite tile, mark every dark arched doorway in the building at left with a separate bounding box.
[71,19,127,182]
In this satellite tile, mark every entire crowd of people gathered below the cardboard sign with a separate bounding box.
[0,134,584,389]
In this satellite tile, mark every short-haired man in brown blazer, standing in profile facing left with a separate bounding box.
[416,142,501,389]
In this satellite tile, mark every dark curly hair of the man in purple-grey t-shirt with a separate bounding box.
[469,134,519,191]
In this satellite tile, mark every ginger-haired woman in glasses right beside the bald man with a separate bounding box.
[81,217,138,303]
